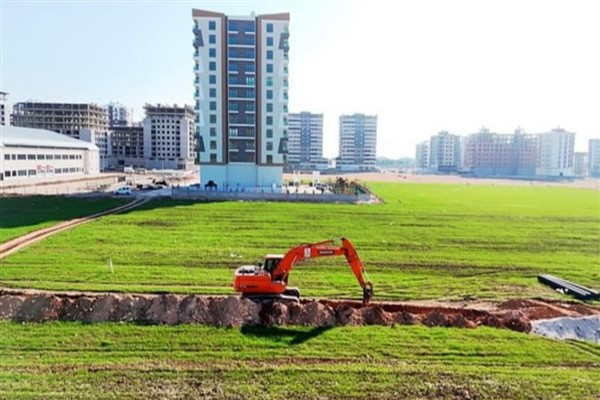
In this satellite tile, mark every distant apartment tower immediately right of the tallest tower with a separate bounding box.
[288,111,327,170]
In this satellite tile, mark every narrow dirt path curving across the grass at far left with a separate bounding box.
[0,198,148,260]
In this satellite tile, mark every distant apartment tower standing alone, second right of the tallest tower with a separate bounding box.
[336,114,377,171]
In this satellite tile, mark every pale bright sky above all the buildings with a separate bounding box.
[0,0,600,158]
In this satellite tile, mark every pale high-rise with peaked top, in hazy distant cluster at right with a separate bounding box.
[536,128,575,177]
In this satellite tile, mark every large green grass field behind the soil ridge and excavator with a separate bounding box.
[0,184,600,300]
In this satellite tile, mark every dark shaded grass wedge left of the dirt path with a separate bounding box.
[0,196,125,243]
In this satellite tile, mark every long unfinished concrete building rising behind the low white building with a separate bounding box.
[12,101,110,170]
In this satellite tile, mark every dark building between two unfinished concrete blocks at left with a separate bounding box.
[109,126,149,168]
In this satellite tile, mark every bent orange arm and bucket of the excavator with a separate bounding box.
[271,238,373,305]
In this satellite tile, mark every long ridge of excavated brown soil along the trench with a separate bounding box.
[0,289,600,332]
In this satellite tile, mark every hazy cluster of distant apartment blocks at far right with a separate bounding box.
[416,128,600,178]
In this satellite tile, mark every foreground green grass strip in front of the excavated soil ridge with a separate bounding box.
[0,323,600,399]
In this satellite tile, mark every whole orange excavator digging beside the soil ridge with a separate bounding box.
[233,238,373,305]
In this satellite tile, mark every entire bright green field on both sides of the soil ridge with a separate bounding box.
[0,184,600,399]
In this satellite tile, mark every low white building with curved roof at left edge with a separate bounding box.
[0,126,100,186]
